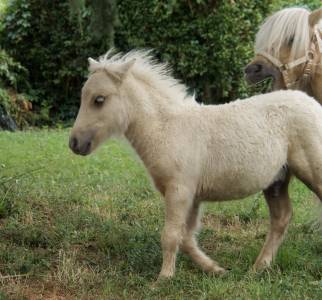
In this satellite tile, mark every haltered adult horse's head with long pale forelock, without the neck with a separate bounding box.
[245,8,322,89]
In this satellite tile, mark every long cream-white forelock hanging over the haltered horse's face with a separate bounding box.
[255,7,321,59]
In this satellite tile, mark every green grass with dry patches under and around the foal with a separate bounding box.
[0,131,322,299]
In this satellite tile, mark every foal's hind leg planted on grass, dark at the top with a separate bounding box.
[254,174,292,269]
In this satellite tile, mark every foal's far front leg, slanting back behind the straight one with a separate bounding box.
[181,203,225,274]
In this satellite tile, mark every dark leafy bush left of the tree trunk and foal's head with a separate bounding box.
[1,0,87,118]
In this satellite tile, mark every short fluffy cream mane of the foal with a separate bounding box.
[90,49,194,101]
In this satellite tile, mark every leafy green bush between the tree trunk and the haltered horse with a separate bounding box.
[115,0,271,103]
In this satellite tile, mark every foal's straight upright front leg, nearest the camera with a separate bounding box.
[159,185,193,279]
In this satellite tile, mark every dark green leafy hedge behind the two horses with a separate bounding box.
[0,0,321,125]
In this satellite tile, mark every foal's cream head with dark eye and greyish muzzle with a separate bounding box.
[69,53,135,155]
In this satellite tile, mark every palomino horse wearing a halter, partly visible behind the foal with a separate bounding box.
[245,8,322,104]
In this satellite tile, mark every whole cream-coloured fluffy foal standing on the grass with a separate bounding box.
[69,51,322,278]
